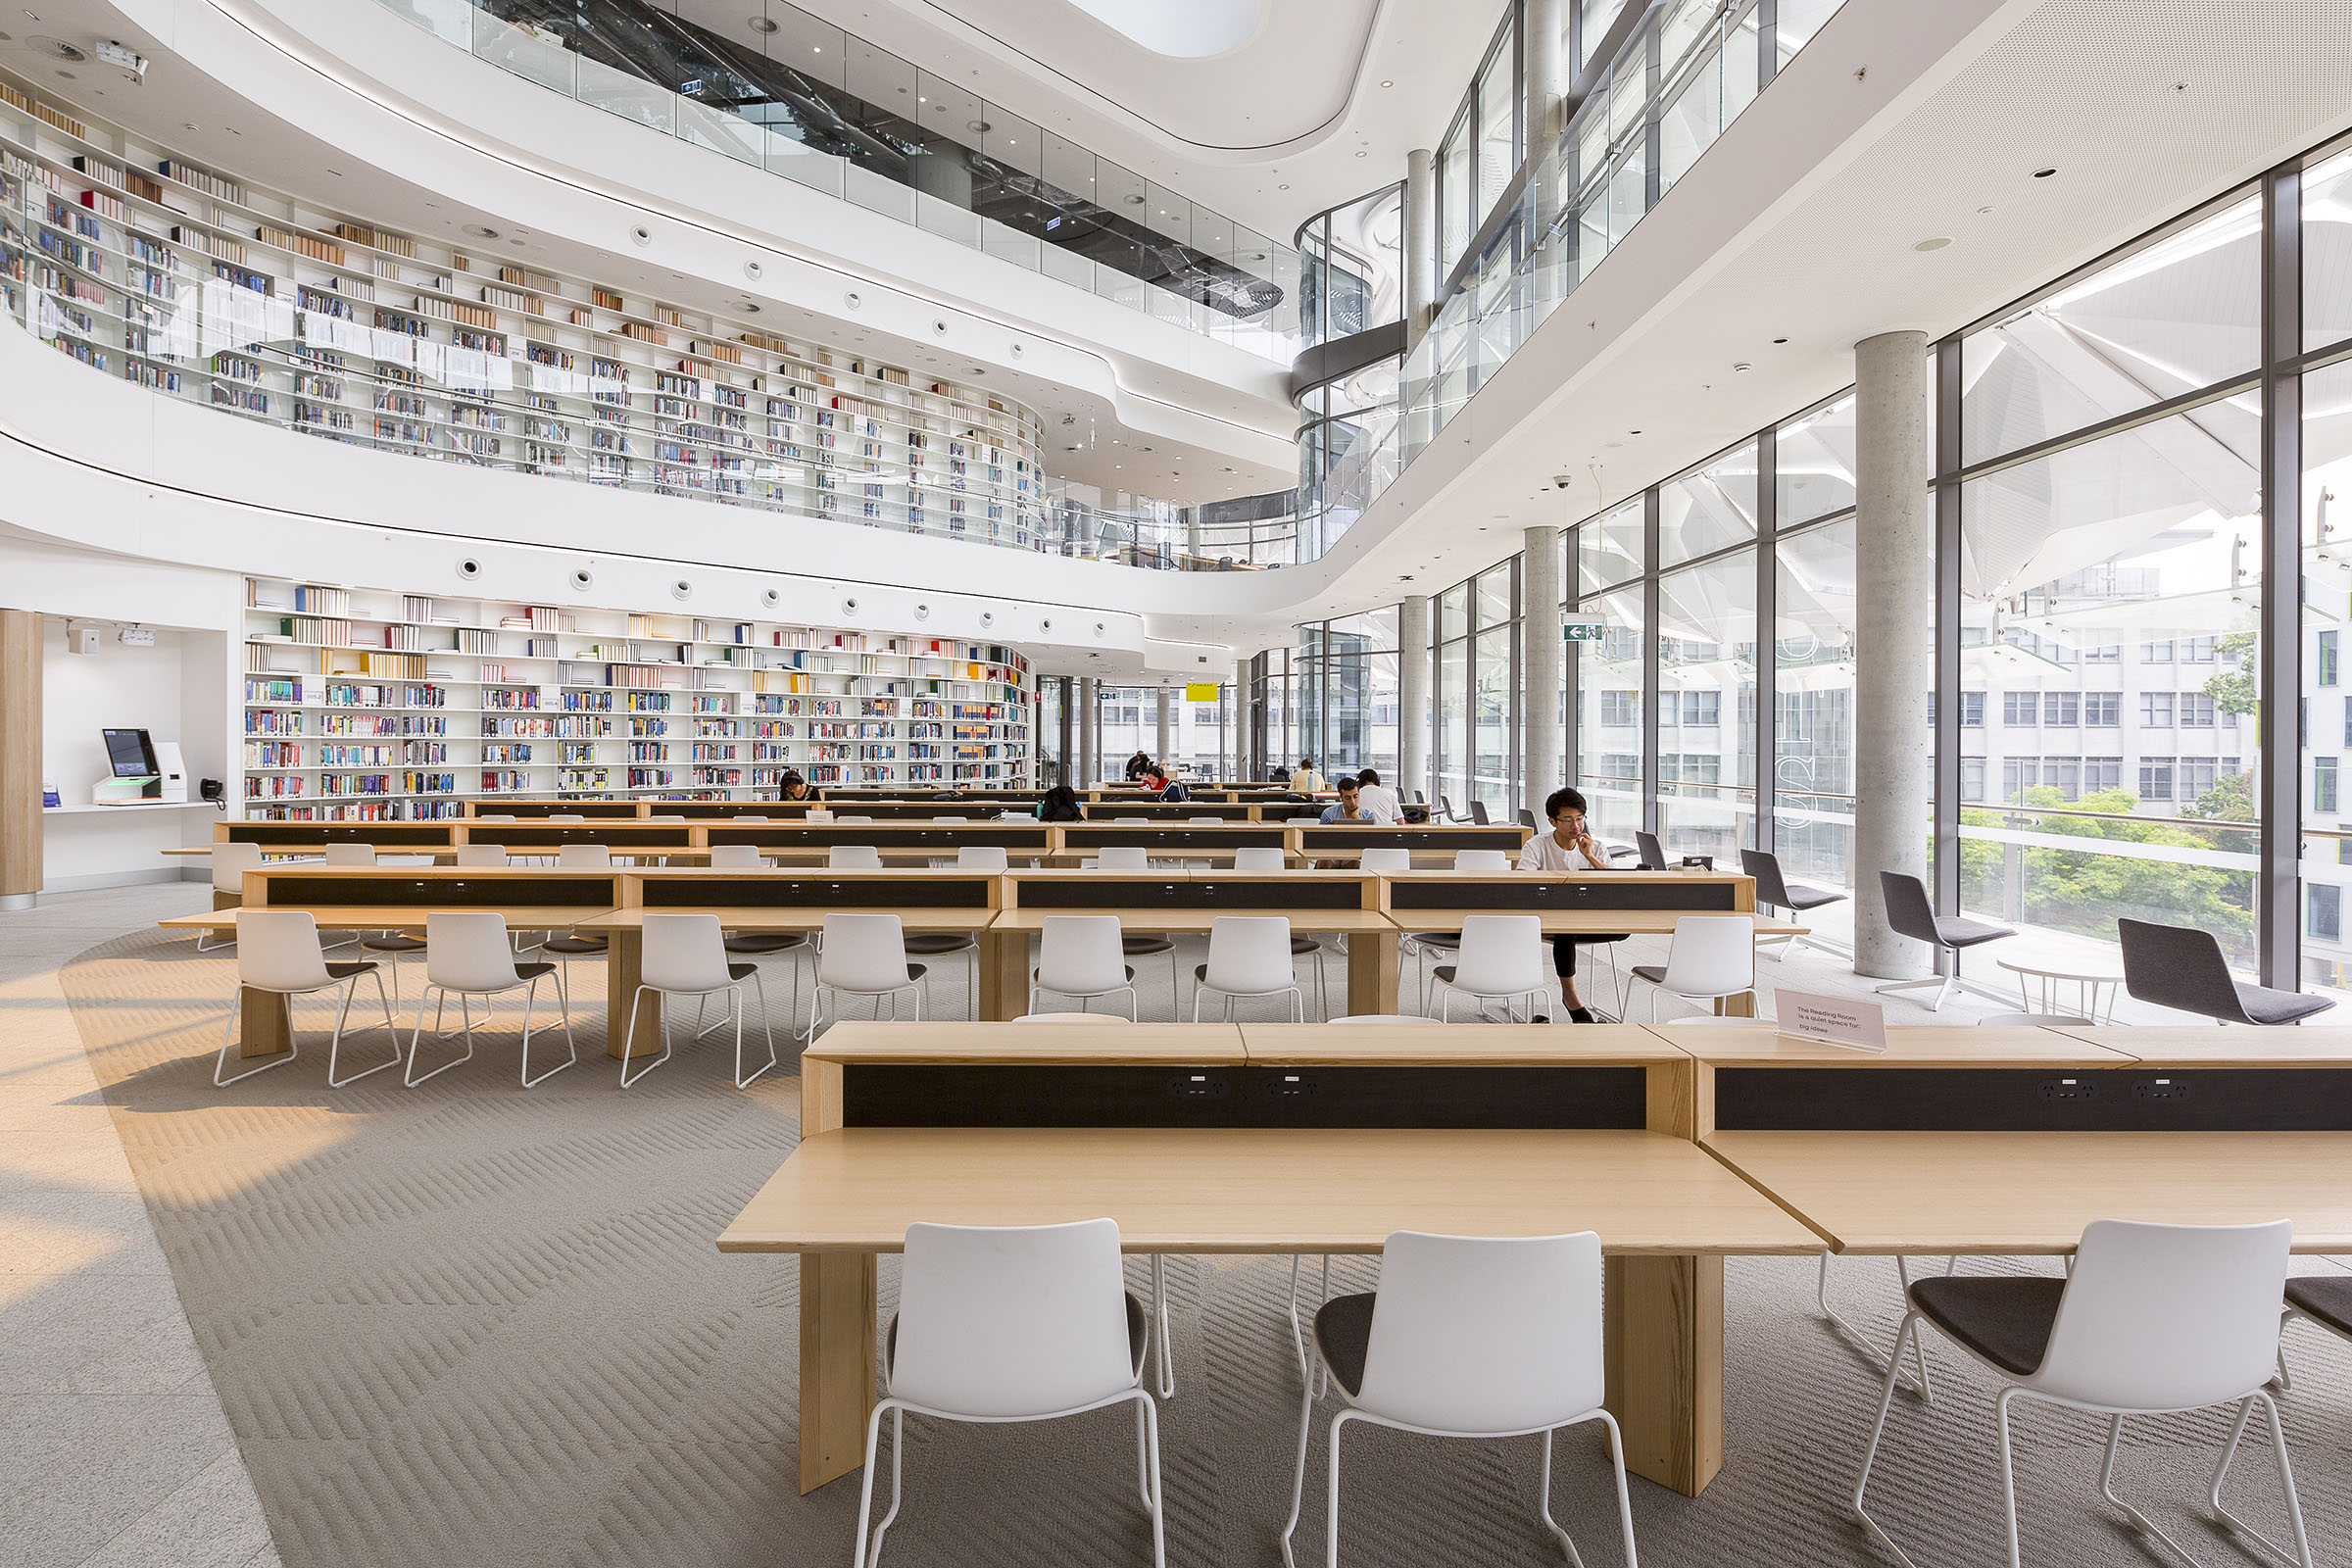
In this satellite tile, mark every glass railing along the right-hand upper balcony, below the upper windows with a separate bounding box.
[1300,0,1841,548]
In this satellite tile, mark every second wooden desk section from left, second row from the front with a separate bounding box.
[578,867,1025,1057]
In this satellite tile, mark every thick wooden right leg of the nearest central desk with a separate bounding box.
[1601,1255,1724,1497]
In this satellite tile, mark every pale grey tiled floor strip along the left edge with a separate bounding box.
[0,884,277,1568]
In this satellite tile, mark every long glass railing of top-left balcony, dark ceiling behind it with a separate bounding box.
[376,0,1298,365]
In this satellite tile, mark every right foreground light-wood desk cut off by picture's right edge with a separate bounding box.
[1658,1025,2352,1253]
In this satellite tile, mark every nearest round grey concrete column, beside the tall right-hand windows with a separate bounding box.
[1851,331,1954,980]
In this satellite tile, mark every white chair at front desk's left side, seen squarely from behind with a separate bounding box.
[856,1222,1166,1568]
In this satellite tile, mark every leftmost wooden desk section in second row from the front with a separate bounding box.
[158,860,633,1055]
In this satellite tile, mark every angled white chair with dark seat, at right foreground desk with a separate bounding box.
[1853,1220,2312,1568]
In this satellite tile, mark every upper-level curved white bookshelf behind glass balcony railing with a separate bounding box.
[0,75,1047,548]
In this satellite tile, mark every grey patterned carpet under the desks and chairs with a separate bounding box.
[50,938,2352,1568]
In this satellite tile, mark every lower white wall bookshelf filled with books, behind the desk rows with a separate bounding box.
[240,578,1035,820]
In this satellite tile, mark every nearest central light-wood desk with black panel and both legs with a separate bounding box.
[717,1025,1821,1493]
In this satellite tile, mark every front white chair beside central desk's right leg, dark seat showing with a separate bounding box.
[1282,1230,1637,1568]
